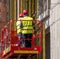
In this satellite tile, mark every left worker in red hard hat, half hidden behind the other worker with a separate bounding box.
[16,13,25,48]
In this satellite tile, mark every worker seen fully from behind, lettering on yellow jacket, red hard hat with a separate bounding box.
[22,10,33,47]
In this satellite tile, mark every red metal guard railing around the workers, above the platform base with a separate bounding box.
[2,20,43,53]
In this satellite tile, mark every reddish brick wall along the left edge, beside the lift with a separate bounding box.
[0,0,7,59]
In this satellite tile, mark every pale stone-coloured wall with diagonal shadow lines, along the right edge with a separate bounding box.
[50,0,60,59]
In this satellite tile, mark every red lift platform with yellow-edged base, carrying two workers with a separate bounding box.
[1,20,43,59]
